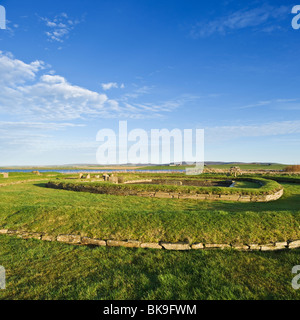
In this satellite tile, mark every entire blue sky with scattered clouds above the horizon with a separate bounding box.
[0,0,300,166]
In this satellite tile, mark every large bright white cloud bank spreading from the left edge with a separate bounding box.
[0,52,183,121]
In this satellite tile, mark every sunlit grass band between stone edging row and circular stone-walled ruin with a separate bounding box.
[0,182,300,243]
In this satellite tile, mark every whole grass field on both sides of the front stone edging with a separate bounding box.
[0,175,300,299]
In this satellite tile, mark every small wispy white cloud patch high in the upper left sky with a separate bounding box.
[41,13,81,43]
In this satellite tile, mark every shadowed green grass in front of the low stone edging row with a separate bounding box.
[0,236,300,300]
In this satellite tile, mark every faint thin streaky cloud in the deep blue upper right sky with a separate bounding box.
[191,5,291,38]
